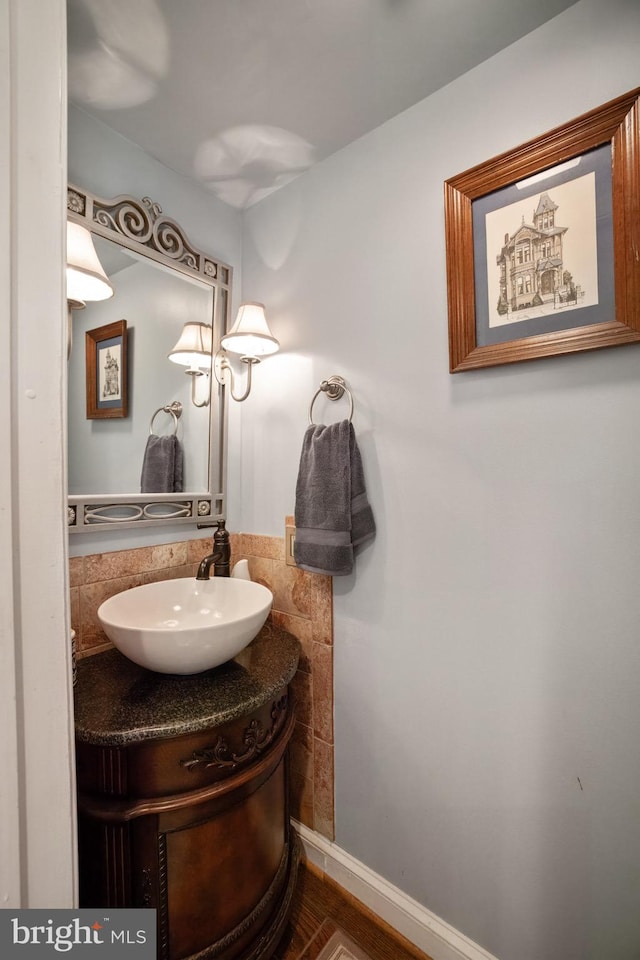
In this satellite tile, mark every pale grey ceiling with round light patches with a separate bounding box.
[67,0,576,207]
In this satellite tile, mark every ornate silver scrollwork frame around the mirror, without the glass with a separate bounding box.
[67,184,233,533]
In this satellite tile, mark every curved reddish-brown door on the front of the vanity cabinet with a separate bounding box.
[158,758,289,960]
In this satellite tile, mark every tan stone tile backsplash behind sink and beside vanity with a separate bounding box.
[70,533,334,840]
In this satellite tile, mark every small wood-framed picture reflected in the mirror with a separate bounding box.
[86,320,128,420]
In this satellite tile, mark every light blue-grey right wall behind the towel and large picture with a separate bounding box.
[241,0,640,960]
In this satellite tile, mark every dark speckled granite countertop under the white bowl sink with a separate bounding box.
[75,624,300,746]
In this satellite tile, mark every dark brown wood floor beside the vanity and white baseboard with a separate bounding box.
[273,864,429,960]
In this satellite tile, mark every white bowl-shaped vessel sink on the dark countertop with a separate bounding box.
[98,577,273,674]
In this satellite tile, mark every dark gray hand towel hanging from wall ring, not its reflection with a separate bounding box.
[293,420,376,576]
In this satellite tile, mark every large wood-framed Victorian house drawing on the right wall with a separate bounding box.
[445,89,640,373]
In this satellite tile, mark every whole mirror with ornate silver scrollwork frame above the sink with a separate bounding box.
[67,186,232,532]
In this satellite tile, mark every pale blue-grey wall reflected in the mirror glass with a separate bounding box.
[68,237,213,494]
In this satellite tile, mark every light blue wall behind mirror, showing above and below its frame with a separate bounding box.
[68,107,242,556]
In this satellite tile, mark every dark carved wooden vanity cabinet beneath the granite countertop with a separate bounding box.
[76,632,299,960]
